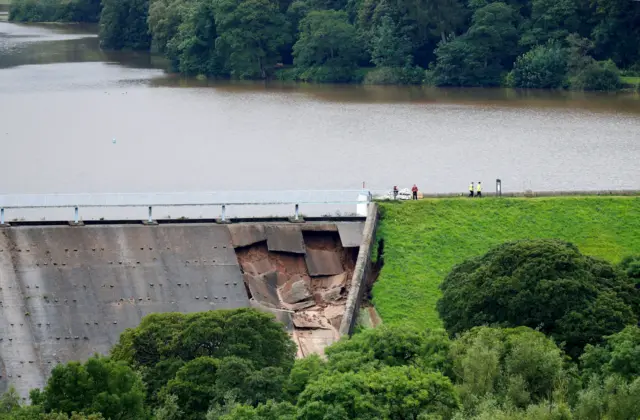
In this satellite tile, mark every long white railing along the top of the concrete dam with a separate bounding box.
[0,190,371,224]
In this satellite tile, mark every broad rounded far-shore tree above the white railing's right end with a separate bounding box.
[293,10,361,82]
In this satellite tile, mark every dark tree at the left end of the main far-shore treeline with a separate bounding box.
[100,0,151,50]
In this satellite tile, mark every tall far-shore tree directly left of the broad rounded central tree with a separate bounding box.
[215,0,290,79]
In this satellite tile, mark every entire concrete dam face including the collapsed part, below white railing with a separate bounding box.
[0,221,364,397]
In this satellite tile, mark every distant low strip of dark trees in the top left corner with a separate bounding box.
[9,0,101,22]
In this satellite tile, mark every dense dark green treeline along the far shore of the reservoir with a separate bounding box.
[10,0,640,90]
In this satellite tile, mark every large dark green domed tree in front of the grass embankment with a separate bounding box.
[438,240,639,357]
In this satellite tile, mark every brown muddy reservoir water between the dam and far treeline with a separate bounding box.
[0,22,640,200]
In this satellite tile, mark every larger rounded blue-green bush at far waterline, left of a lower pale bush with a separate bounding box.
[513,43,567,89]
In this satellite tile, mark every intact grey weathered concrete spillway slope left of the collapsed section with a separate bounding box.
[0,224,249,396]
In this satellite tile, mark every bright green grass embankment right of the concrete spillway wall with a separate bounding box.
[373,197,640,328]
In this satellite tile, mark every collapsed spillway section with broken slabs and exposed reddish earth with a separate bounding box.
[234,222,364,357]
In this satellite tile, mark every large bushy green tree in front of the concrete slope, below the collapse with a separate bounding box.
[112,309,295,412]
